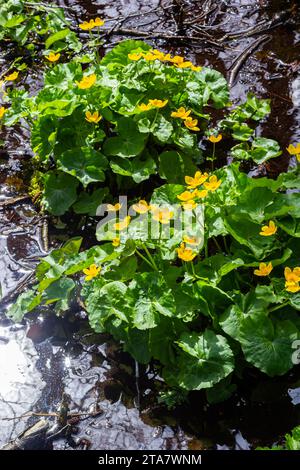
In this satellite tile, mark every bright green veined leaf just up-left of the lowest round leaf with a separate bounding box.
[129,272,175,330]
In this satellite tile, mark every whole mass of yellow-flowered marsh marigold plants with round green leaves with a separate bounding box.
[3,32,300,401]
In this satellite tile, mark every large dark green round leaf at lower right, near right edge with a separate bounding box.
[239,314,299,377]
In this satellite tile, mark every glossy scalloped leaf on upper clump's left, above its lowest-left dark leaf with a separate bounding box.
[59,147,107,187]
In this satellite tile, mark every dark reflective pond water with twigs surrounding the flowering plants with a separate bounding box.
[0,0,300,449]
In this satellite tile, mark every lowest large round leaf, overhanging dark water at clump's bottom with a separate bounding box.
[164,329,234,390]
